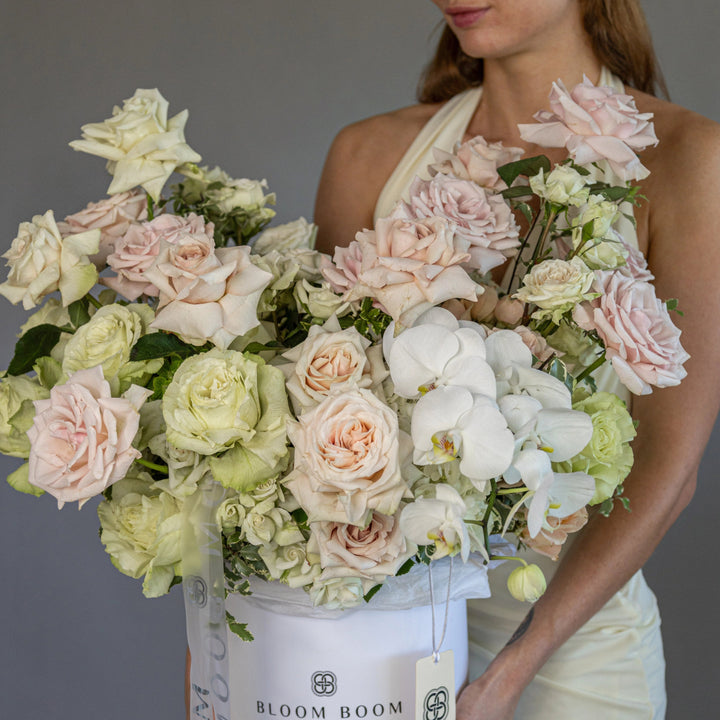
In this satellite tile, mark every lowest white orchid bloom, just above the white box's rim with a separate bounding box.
[400,485,470,561]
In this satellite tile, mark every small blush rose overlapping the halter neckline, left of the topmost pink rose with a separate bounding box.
[428,135,524,190]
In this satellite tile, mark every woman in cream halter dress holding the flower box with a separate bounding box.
[315,0,720,720]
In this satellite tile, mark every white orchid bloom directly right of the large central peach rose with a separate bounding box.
[411,386,515,481]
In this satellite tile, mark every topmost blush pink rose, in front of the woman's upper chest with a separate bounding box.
[518,78,658,182]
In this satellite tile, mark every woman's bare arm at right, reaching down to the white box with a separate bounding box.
[457,113,720,720]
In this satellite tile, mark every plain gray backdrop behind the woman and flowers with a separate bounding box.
[0,0,720,720]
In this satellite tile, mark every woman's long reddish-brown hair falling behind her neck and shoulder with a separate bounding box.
[418,0,668,103]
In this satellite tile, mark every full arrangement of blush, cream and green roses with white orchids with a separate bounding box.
[0,80,687,632]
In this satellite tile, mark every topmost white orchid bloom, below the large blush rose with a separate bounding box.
[383,308,495,398]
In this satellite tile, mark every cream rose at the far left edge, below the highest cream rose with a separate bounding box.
[0,210,100,310]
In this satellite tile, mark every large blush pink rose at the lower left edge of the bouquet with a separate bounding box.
[28,366,151,508]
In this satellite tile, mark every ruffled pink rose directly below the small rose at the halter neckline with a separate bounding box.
[403,175,520,274]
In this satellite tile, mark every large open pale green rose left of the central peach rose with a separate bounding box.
[163,348,290,492]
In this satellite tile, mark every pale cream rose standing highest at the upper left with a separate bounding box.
[70,90,201,200]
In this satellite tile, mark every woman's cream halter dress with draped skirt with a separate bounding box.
[374,69,666,720]
